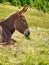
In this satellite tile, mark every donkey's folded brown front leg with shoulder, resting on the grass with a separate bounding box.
[2,26,15,45]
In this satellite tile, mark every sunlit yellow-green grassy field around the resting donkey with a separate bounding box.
[0,4,49,65]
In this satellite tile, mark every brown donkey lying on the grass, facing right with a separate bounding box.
[0,5,30,44]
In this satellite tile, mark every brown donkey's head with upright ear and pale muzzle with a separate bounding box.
[14,5,30,37]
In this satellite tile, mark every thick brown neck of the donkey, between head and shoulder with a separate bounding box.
[1,12,16,33]
